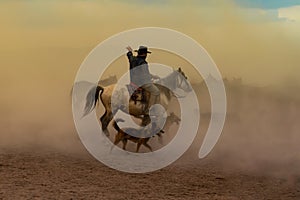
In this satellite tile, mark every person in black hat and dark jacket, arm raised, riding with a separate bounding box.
[126,46,160,115]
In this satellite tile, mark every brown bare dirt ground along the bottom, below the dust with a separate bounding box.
[0,144,300,199]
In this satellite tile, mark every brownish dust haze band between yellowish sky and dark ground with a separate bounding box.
[0,77,300,180]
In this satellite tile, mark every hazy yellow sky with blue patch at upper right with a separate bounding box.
[0,0,300,90]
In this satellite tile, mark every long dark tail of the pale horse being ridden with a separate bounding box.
[83,85,104,117]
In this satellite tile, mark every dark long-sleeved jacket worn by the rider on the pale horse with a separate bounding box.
[127,51,151,86]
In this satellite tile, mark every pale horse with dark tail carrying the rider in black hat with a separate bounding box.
[84,68,192,135]
